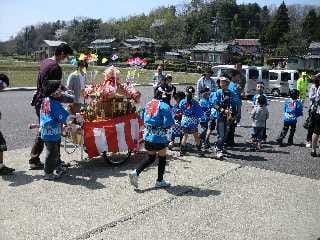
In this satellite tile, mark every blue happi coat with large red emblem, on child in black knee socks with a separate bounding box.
[142,99,174,144]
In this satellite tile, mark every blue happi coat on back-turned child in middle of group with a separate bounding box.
[179,98,203,129]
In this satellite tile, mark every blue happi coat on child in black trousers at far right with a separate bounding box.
[283,98,303,123]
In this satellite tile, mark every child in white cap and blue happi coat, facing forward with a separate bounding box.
[210,77,237,159]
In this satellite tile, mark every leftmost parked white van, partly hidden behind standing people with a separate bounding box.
[212,65,259,96]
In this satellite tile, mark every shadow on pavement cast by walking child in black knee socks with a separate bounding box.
[135,185,221,197]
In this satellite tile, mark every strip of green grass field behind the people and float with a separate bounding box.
[0,61,200,87]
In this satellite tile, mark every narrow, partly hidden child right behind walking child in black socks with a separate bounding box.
[168,92,186,149]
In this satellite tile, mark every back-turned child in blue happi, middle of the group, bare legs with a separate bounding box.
[179,86,203,156]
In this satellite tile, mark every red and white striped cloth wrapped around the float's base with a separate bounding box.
[83,114,143,158]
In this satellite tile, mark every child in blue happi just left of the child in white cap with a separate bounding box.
[199,87,216,149]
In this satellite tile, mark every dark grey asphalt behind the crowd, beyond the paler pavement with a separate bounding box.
[0,87,320,179]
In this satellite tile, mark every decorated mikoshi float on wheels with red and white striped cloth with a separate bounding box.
[66,66,143,164]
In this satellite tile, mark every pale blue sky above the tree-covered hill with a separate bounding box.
[0,0,320,41]
